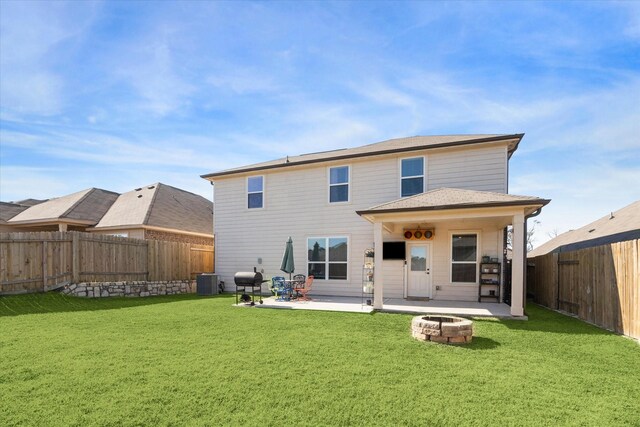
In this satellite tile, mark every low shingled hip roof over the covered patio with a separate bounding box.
[356,188,549,215]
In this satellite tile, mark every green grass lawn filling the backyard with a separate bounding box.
[0,294,640,426]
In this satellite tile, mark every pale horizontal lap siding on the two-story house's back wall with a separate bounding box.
[214,144,506,299]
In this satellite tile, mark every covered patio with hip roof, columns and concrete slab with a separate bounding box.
[357,188,549,318]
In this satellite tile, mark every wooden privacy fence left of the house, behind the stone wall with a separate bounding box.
[0,231,214,295]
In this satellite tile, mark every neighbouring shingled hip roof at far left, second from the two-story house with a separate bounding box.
[8,188,118,225]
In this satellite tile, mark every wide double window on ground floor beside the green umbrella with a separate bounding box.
[307,237,349,280]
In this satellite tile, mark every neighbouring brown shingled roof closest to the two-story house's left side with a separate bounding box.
[94,183,213,235]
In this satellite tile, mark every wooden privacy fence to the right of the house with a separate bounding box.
[527,240,640,339]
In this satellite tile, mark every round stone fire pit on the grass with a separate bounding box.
[411,315,473,344]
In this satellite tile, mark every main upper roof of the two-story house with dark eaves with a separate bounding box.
[201,133,524,179]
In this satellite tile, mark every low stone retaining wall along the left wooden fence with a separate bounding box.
[61,280,196,298]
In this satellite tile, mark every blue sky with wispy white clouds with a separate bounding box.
[0,0,640,244]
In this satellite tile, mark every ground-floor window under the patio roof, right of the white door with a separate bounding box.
[451,231,479,283]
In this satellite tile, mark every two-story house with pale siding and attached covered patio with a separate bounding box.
[203,134,549,316]
